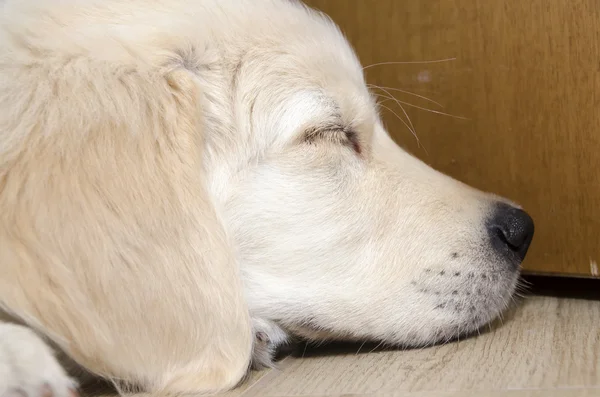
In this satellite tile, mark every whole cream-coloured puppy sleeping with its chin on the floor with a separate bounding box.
[0,0,534,397]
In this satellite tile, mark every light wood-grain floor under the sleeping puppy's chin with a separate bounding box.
[224,297,600,397]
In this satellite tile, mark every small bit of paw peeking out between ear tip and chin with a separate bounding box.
[252,318,288,369]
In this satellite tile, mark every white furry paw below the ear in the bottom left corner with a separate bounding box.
[0,323,77,397]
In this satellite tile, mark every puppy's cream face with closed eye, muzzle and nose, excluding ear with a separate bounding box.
[207,1,533,345]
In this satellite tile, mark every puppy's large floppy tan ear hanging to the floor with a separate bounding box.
[0,2,252,392]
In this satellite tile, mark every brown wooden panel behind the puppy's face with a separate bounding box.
[307,0,600,276]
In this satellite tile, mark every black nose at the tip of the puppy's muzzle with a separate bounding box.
[488,203,534,266]
